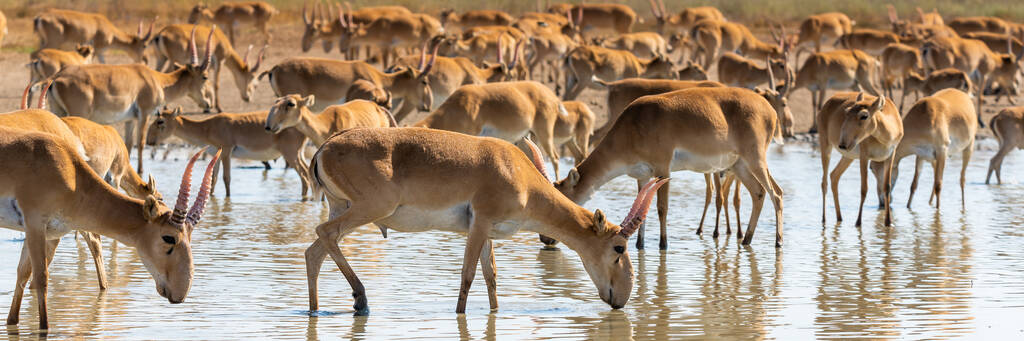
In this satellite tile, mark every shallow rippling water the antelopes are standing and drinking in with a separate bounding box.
[0,139,1024,340]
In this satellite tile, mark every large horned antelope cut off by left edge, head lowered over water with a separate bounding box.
[0,128,217,330]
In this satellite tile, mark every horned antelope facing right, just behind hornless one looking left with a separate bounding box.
[260,45,436,122]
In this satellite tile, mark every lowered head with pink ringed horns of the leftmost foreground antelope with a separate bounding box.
[134,151,220,303]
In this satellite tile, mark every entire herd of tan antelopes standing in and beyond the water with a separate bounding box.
[0,0,1024,329]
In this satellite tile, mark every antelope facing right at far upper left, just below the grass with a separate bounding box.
[33,9,154,62]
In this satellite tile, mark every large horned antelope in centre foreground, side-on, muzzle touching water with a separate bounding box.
[305,128,668,315]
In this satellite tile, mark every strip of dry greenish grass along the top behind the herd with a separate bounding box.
[0,0,1024,30]
